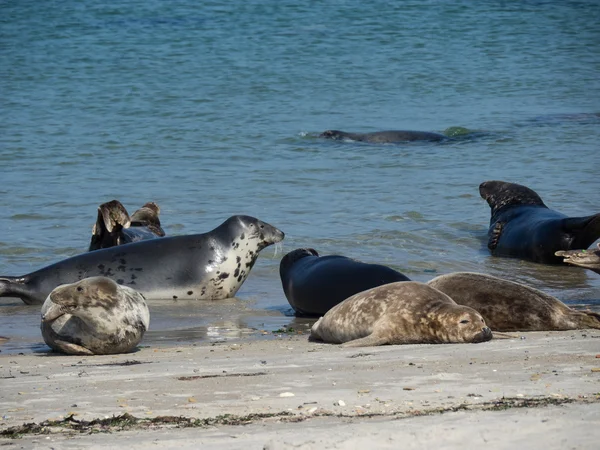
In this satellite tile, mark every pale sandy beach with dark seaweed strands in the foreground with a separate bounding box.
[0,330,600,449]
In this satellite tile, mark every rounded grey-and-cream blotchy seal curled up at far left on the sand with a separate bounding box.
[41,277,150,355]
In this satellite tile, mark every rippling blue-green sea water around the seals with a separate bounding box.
[0,0,600,352]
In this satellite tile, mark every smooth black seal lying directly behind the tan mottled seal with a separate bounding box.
[279,248,410,317]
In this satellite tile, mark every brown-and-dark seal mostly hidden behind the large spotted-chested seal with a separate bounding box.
[88,200,165,251]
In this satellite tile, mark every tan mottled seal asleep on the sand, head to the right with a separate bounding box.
[310,281,492,347]
